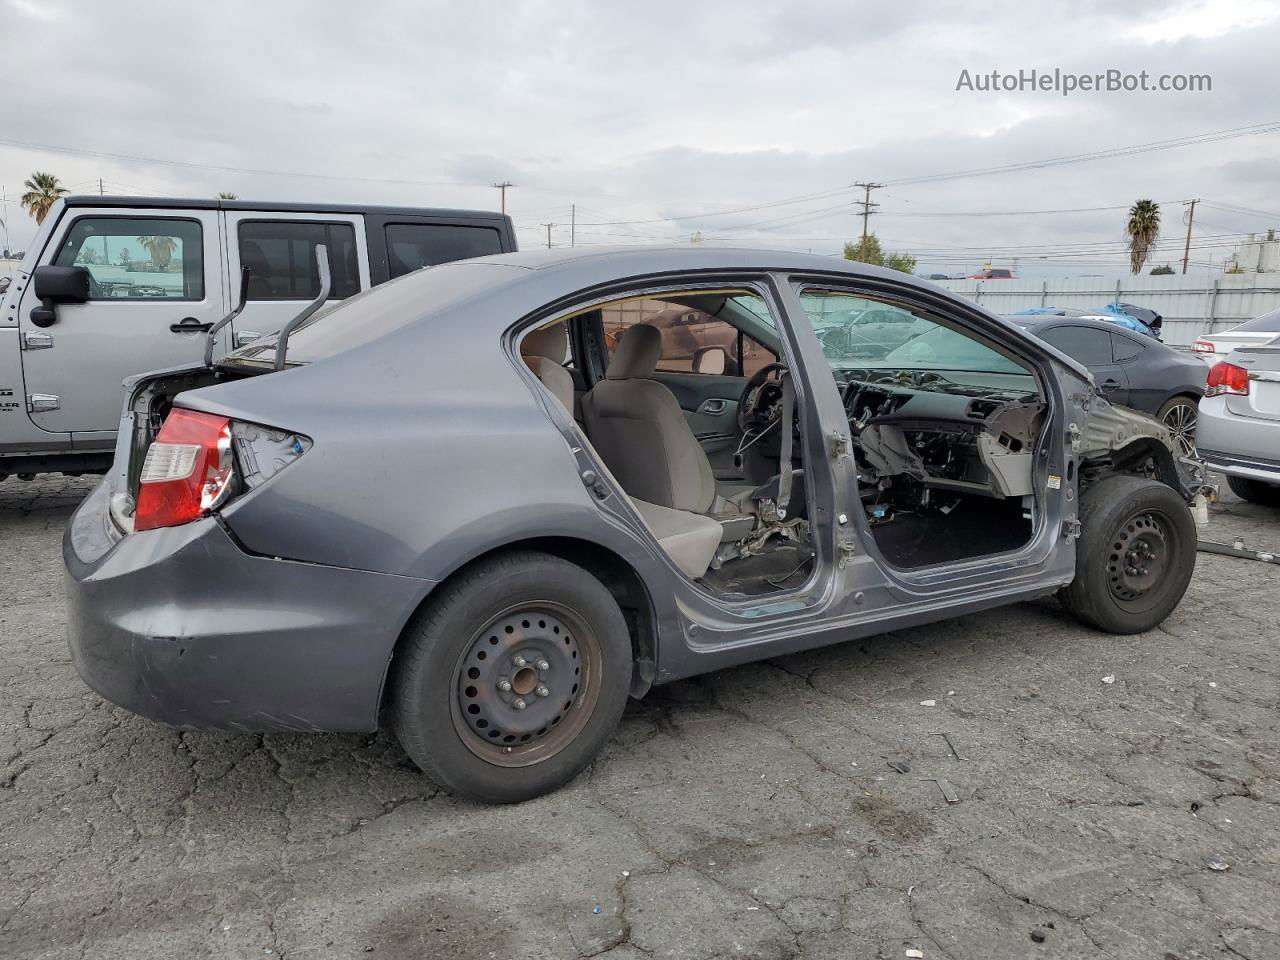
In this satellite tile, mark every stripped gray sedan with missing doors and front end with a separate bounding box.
[64,248,1198,803]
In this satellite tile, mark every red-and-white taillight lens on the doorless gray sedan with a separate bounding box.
[133,407,236,530]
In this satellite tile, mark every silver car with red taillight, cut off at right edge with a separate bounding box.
[1197,337,1280,506]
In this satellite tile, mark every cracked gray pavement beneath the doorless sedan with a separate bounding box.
[0,479,1280,960]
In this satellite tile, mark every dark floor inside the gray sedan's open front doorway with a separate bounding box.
[870,494,1032,570]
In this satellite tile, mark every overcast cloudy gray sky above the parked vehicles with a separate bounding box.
[0,0,1280,275]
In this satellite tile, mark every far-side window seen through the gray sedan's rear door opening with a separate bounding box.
[600,293,777,376]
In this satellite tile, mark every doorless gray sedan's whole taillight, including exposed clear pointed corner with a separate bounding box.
[133,407,311,530]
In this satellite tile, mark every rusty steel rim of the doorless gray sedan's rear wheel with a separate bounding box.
[449,600,602,767]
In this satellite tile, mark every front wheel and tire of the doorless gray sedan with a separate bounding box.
[1060,476,1197,634]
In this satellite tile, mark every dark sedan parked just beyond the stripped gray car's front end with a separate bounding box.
[1006,316,1204,454]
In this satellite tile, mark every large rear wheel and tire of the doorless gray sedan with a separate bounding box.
[390,552,632,804]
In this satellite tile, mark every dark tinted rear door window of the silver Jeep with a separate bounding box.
[238,220,360,300]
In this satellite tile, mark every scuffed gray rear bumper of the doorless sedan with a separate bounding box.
[63,484,431,731]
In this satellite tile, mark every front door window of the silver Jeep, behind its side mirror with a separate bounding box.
[54,216,205,300]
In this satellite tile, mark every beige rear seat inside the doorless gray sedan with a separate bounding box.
[520,323,722,580]
